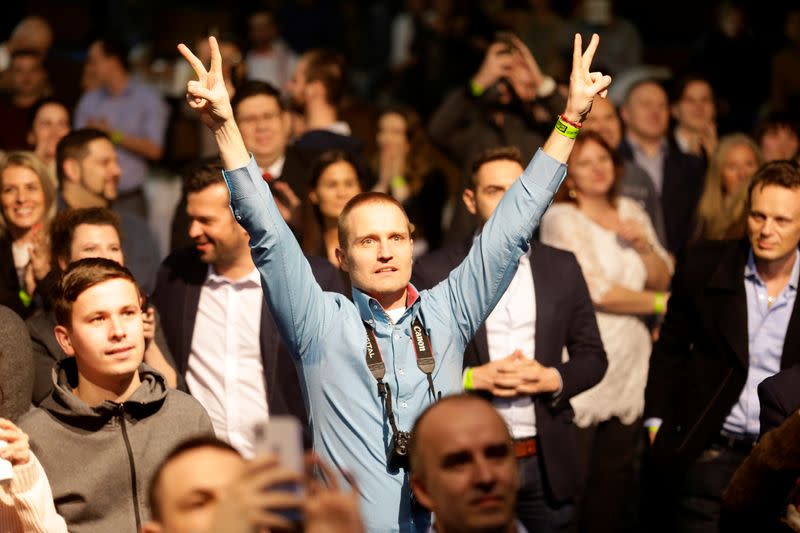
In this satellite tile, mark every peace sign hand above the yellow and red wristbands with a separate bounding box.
[565,33,611,122]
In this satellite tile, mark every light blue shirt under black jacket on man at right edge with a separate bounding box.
[722,250,800,439]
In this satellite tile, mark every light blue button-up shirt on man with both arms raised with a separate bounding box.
[225,150,566,532]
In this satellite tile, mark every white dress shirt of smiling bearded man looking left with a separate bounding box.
[186,266,269,457]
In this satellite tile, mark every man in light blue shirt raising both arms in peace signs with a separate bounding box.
[179,36,611,531]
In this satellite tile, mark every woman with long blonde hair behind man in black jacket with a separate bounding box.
[692,133,762,241]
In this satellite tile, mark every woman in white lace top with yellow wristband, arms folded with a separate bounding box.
[541,132,672,531]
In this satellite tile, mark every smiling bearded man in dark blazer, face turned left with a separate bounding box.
[153,165,341,456]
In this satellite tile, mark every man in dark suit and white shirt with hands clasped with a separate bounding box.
[412,148,607,531]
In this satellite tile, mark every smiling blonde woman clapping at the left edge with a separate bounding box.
[0,152,56,317]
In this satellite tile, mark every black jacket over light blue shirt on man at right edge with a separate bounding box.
[645,240,800,473]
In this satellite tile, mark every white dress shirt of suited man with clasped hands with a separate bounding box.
[486,250,536,439]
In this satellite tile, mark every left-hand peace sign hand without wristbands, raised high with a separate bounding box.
[178,37,233,131]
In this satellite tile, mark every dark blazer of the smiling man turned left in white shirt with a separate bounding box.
[152,248,344,425]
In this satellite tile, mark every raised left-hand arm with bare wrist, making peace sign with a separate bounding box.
[178,37,336,356]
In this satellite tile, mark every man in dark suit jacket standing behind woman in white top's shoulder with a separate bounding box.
[618,80,705,255]
